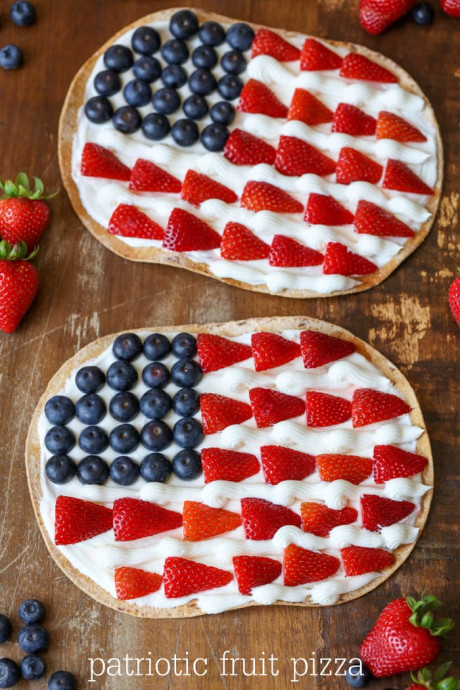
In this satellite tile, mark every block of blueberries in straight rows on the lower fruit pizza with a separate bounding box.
[45,333,203,486]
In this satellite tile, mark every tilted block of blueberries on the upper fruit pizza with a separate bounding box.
[85,10,254,151]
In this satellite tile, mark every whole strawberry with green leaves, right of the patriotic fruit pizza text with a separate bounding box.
[360,595,454,678]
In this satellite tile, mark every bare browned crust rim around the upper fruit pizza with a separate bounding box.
[58,7,443,299]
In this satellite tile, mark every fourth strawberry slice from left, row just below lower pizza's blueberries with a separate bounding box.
[241,498,300,541]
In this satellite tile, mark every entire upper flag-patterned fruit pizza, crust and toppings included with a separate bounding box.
[60,10,442,297]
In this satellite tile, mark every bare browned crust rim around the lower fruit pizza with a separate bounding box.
[25,316,434,618]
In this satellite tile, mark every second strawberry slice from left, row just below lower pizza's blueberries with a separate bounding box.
[113,498,182,541]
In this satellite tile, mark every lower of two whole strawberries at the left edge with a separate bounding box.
[0,240,39,333]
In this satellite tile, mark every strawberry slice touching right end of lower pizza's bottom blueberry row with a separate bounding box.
[201,448,260,484]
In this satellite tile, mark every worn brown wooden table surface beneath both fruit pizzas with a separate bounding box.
[0,0,460,690]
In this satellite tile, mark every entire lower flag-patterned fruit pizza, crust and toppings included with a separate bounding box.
[27,317,433,617]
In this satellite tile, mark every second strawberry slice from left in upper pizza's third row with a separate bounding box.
[275,135,336,177]
